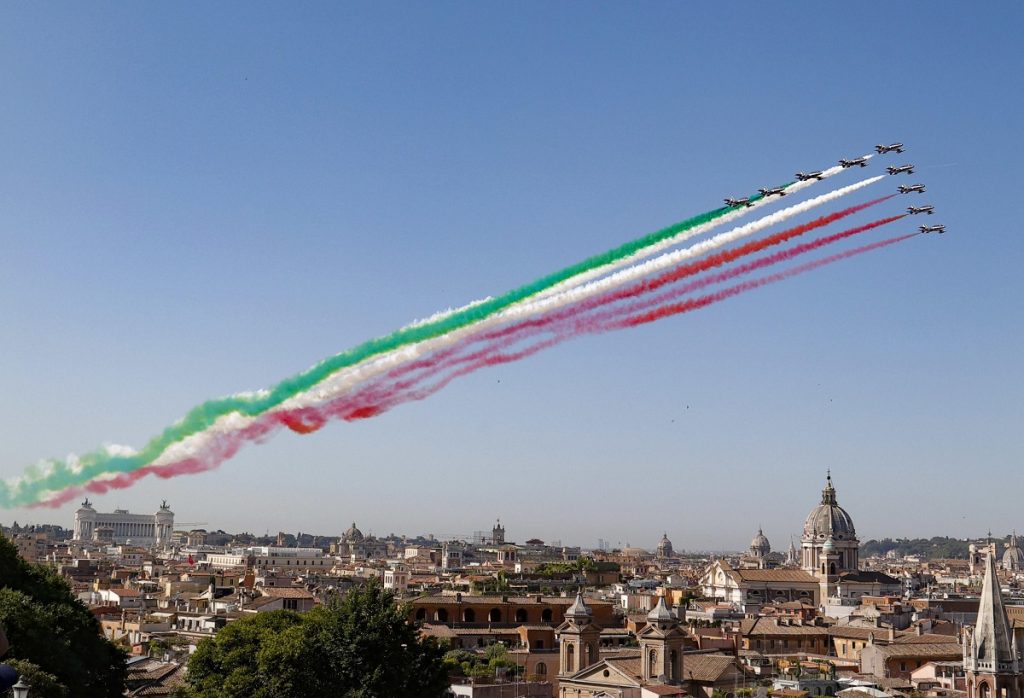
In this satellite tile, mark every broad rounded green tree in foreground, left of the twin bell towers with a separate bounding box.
[178,581,449,698]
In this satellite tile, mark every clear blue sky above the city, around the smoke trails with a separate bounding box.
[0,2,1024,549]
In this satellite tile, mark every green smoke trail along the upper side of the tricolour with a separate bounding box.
[0,193,770,508]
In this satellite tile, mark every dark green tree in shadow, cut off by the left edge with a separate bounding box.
[0,536,125,698]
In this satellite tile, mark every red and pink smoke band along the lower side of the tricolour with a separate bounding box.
[34,211,918,506]
